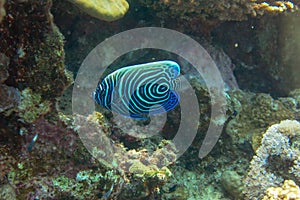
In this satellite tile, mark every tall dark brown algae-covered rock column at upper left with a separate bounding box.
[0,0,71,100]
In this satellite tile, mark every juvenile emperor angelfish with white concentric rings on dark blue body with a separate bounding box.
[93,60,180,119]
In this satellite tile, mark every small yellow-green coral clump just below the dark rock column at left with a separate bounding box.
[16,88,51,123]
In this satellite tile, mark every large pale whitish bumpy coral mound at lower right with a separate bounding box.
[244,120,300,200]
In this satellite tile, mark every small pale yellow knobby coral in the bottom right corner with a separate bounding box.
[263,180,300,200]
